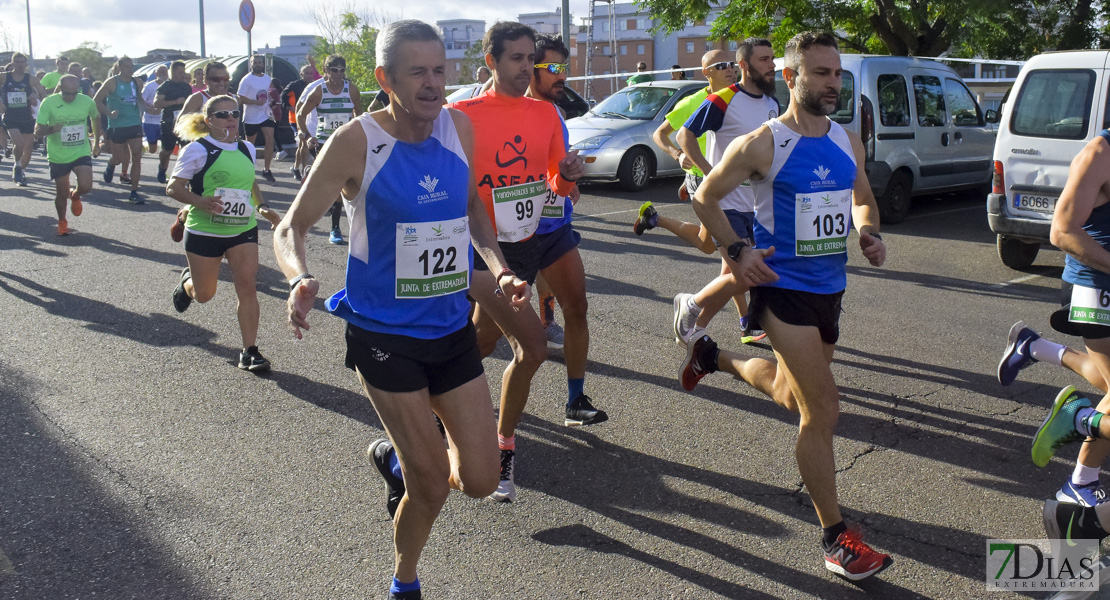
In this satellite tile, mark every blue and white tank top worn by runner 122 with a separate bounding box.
[326,109,474,339]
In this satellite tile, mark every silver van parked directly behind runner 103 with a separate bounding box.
[775,54,995,223]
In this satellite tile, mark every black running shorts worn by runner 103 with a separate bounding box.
[748,286,844,344]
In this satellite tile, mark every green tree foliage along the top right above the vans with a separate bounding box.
[636,0,1110,59]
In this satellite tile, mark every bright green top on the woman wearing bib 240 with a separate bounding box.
[185,139,258,237]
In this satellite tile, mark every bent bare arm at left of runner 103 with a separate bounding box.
[684,126,778,285]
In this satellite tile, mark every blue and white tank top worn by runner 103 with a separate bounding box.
[751,119,856,294]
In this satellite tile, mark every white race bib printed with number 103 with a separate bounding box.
[794,190,851,256]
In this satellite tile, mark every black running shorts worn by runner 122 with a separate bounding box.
[345,322,485,396]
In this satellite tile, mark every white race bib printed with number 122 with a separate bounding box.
[395,216,471,298]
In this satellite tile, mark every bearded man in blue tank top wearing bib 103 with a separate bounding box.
[680,32,891,580]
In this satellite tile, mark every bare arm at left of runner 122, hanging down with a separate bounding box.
[274,117,366,339]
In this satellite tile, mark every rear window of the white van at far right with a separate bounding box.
[1010,69,1094,140]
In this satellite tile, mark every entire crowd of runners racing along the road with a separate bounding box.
[19,12,1110,599]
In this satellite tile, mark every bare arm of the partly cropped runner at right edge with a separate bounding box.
[1049,135,1110,273]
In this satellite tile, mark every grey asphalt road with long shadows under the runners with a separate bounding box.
[0,150,1091,599]
